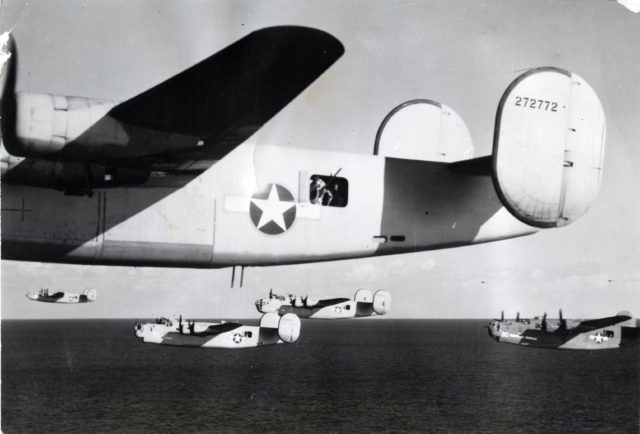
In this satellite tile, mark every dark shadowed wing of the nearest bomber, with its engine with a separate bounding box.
[3,26,344,181]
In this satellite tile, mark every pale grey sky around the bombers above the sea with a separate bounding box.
[0,0,640,318]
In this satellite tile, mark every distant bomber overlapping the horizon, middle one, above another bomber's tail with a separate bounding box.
[256,289,391,319]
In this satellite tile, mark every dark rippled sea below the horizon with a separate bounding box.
[2,319,640,433]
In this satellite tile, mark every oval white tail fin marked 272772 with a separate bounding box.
[493,67,605,228]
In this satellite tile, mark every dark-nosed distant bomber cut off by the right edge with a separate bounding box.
[488,311,640,350]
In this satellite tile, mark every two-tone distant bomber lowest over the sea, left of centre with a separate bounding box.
[135,313,300,348]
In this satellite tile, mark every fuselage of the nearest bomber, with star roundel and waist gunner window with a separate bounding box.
[2,142,536,268]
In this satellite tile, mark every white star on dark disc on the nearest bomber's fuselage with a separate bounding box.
[249,184,296,235]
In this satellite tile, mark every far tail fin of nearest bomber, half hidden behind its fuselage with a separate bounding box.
[373,99,473,163]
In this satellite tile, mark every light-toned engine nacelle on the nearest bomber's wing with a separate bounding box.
[4,92,128,158]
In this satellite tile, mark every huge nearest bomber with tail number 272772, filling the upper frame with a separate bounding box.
[1,26,606,268]
